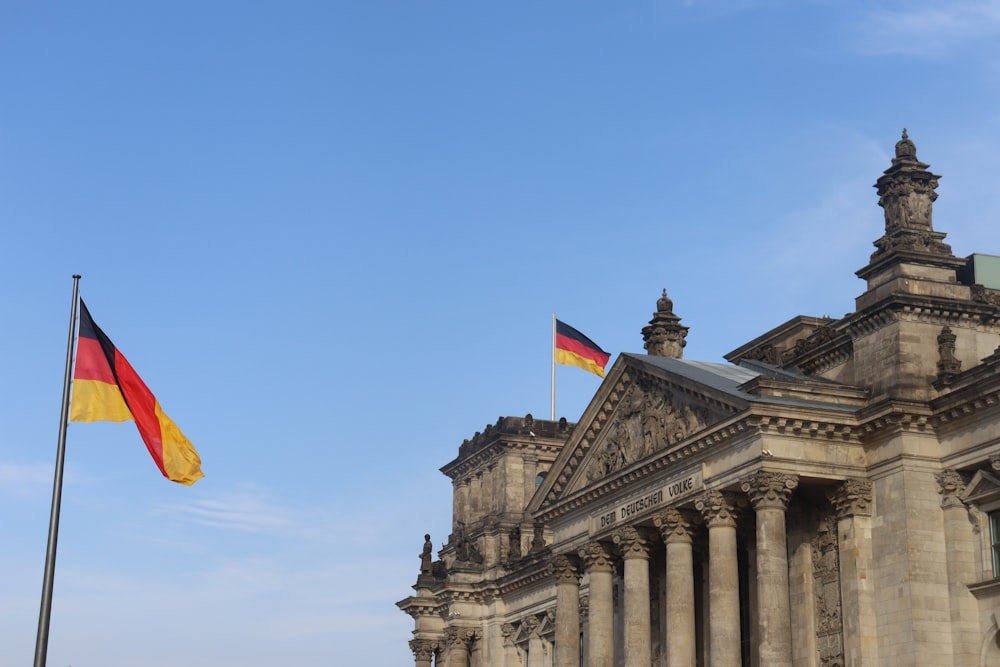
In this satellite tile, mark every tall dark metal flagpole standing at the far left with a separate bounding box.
[35,274,80,667]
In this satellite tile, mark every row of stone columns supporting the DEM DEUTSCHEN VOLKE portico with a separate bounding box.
[414,471,873,667]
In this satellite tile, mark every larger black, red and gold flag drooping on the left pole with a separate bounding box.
[70,299,204,486]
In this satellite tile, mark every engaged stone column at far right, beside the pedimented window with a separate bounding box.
[937,470,980,665]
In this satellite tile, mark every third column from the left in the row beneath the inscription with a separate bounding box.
[613,526,652,667]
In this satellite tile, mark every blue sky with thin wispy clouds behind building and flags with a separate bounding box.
[0,0,1000,667]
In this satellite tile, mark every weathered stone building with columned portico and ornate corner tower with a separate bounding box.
[398,131,1000,667]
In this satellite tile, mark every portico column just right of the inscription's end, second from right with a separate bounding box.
[695,490,748,667]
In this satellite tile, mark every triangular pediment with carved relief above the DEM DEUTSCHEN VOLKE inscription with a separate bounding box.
[528,354,755,511]
